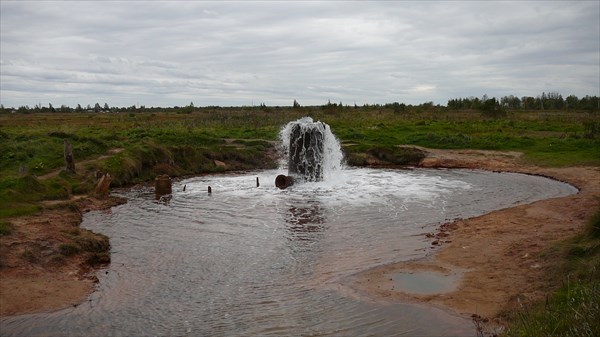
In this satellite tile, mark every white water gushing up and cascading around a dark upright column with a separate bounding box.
[279,117,344,181]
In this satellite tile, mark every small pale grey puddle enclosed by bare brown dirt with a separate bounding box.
[393,271,462,295]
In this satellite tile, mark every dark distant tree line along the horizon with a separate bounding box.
[0,92,600,116]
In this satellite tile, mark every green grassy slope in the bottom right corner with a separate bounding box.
[505,210,600,337]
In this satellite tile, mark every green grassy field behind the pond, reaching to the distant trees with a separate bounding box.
[0,106,600,219]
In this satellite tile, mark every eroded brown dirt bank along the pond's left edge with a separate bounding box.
[0,197,125,316]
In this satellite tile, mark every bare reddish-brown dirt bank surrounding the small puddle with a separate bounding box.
[352,149,600,321]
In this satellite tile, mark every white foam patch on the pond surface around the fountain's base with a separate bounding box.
[182,168,472,206]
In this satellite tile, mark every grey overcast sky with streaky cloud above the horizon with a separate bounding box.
[0,0,600,107]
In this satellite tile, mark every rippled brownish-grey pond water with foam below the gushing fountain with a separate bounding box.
[1,169,576,336]
